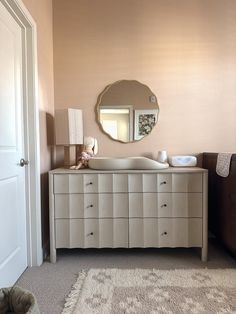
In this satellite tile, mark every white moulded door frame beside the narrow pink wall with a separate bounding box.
[0,0,43,266]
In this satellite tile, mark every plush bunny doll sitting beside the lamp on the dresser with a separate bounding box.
[71,136,98,169]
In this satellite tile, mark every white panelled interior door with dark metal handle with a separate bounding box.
[0,2,27,288]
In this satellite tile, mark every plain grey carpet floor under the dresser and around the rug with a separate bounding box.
[17,239,236,314]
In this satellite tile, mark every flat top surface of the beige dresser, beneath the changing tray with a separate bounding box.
[49,167,208,174]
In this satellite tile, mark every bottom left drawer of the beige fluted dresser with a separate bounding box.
[55,218,128,248]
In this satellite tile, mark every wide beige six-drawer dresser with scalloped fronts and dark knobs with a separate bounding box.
[49,167,208,262]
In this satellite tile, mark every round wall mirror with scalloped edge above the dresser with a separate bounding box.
[96,80,159,143]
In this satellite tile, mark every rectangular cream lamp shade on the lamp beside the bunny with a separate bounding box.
[55,108,83,145]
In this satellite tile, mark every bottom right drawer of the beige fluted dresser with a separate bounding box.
[129,218,202,247]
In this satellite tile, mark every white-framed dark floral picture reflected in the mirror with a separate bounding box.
[134,109,158,140]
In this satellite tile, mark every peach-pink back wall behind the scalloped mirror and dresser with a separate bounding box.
[53,0,236,164]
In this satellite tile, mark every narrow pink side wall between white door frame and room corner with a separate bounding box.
[23,0,54,253]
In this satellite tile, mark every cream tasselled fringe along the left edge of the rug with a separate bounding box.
[61,270,87,314]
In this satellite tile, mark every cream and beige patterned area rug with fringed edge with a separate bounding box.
[62,269,236,314]
